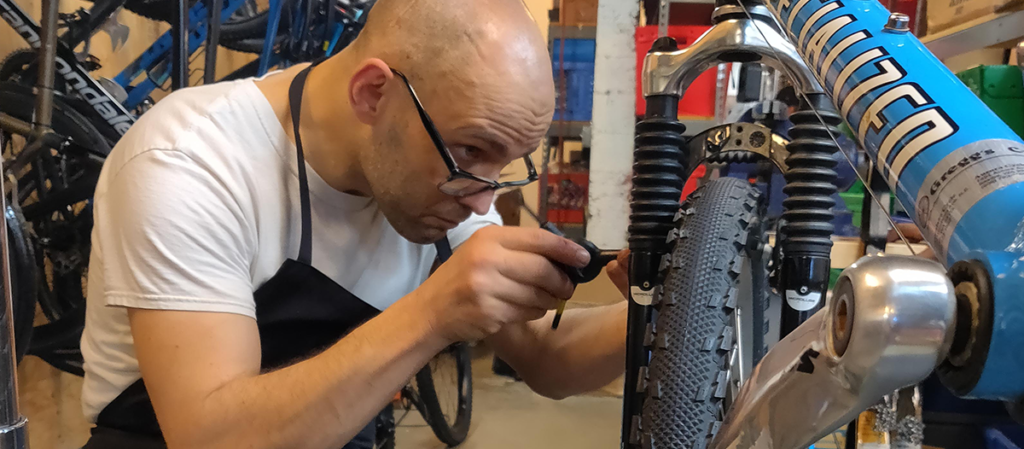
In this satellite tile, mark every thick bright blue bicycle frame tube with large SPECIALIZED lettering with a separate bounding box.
[766,0,1024,400]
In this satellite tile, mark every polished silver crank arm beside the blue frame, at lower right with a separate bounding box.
[711,255,956,449]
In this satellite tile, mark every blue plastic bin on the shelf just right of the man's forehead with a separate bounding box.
[551,39,596,122]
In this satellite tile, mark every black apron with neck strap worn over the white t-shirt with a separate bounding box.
[83,66,452,449]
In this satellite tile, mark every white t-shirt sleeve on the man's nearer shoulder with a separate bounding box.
[93,150,256,318]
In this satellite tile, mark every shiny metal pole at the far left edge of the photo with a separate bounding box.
[0,136,27,449]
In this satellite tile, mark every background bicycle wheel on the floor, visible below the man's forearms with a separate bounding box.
[416,343,473,446]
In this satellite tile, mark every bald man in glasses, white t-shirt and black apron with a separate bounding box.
[82,0,626,449]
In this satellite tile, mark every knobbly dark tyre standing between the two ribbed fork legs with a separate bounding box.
[639,177,768,448]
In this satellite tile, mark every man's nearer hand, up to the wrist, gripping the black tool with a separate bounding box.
[413,227,590,342]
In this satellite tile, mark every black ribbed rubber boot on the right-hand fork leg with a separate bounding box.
[779,93,842,335]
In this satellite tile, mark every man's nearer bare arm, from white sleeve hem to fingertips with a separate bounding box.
[129,227,587,449]
